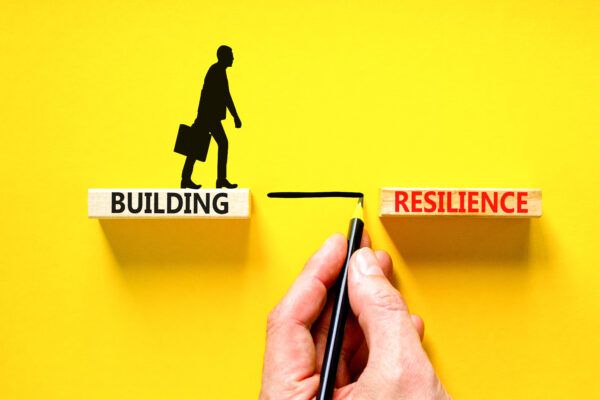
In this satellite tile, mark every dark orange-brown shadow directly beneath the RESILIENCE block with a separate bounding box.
[381,216,530,266]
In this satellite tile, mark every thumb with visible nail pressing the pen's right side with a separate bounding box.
[348,248,422,368]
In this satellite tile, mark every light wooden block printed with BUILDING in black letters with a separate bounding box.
[88,189,250,218]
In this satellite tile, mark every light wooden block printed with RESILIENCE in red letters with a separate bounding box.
[379,188,542,217]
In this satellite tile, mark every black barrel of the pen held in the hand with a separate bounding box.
[317,218,364,400]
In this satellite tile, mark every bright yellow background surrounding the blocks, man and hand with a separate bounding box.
[0,0,600,400]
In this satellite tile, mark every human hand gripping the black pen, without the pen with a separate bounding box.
[260,234,450,400]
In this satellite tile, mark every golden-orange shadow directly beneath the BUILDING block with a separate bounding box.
[100,219,250,267]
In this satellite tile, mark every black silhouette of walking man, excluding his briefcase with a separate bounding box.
[181,46,242,189]
